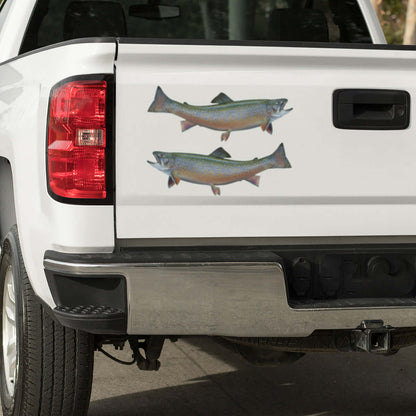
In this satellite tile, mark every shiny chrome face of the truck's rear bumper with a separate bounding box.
[44,259,416,337]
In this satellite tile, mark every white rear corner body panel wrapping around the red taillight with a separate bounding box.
[0,41,116,306]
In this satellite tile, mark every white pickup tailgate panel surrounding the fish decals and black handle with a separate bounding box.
[116,42,416,239]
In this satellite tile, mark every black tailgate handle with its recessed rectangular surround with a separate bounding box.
[333,89,410,130]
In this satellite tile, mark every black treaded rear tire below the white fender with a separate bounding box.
[0,227,94,416]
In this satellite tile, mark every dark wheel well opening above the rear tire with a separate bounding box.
[0,157,16,241]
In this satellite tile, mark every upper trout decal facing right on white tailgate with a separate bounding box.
[147,87,292,141]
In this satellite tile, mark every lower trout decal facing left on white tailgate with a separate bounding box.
[148,143,291,195]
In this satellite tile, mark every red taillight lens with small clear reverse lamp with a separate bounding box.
[48,81,107,199]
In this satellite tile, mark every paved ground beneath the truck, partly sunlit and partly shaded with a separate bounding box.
[89,338,416,416]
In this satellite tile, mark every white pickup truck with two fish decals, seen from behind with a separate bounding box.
[0,0,416,416]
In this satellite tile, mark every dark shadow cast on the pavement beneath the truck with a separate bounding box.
[89,341,416,416]
